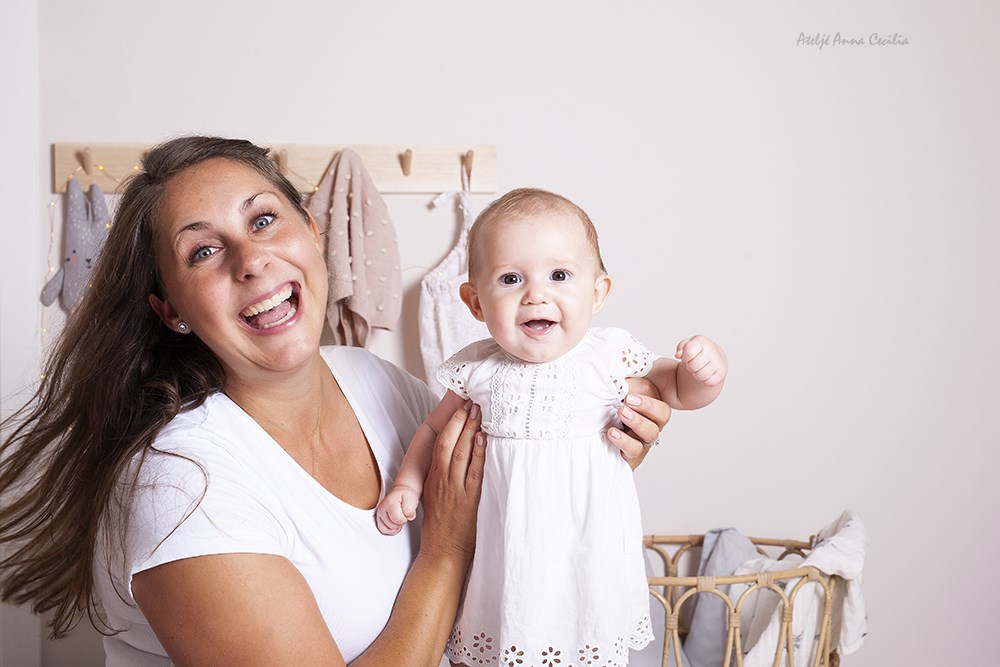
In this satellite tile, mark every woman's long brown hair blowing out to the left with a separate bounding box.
[0,137,305,637]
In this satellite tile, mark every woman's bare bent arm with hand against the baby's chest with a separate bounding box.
[132,400,485,667]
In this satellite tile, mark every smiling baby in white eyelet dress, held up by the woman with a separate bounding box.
[376,189,728,665]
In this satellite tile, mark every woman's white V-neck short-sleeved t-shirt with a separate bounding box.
[95,347,436,667]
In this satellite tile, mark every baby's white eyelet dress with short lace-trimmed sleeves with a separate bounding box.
[438,329,655,667]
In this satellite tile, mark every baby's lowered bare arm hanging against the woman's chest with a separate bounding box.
[375,390,465,535]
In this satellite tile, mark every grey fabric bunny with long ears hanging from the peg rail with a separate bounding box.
[42,178,108,310]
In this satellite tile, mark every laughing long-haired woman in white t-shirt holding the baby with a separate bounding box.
[0,137,669,665]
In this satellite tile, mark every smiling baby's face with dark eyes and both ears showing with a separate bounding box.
[462,211,611,363]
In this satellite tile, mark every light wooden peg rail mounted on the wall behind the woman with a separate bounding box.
[52,142,497,193]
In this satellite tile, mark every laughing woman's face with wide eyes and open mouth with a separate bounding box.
[150,158,327,382]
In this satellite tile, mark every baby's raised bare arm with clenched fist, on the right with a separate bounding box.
[647,336,729,410]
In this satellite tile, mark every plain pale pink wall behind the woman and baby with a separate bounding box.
[3,0,1000,667]
